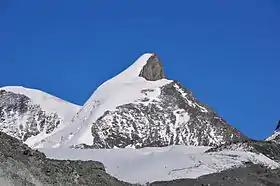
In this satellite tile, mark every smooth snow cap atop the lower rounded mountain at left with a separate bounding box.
[0,86,80,118]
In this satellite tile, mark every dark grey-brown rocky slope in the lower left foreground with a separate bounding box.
[0,132,130,186]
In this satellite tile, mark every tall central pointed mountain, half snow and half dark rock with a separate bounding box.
[34,53,247,148]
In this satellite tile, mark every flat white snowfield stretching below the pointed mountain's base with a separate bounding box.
[39,145,279,184]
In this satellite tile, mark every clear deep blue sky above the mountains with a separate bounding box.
[0,0,280,139]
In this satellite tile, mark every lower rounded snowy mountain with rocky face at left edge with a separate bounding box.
[0,86,80,146]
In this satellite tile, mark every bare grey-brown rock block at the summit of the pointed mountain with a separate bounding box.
[139,53,166,81]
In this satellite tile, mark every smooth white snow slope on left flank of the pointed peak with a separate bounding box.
[39,53,172,147]
